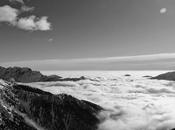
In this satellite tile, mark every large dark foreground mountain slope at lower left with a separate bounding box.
[0,79,102,130]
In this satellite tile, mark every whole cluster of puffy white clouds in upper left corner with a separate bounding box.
[0,0,51,31]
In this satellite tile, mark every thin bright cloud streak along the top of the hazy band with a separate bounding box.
[0,53,175,64]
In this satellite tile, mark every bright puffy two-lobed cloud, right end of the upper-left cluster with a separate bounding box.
[17,15,51,31]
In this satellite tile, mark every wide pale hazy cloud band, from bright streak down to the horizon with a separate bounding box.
[1,53,175,70]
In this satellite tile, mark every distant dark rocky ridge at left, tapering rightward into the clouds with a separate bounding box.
[0,67,85,83]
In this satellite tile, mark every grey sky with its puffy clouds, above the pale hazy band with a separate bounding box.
[0,0,175,69]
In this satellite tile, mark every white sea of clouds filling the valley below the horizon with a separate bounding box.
[27,72,175,130]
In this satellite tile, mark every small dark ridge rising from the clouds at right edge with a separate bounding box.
[151,72,175,81]
